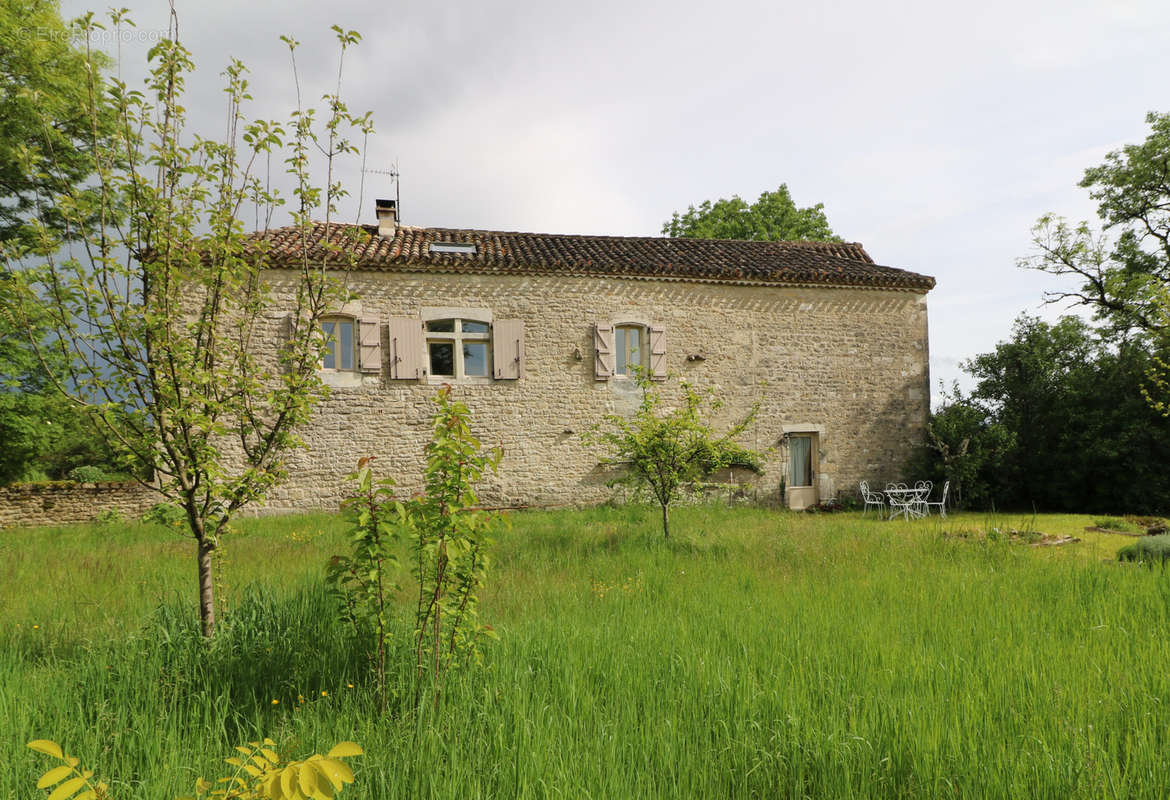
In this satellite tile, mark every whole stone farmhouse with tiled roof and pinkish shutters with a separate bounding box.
[257,201,935,510]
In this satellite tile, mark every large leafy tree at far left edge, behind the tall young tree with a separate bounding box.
[0,0,119,483]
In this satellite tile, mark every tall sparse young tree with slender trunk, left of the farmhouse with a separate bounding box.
[2,13,370,636]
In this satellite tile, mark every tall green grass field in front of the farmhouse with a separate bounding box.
[0,506,1170,800]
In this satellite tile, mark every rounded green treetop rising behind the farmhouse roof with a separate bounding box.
[662,184,841,242]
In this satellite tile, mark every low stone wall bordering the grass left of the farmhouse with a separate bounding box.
[0,482,161,527]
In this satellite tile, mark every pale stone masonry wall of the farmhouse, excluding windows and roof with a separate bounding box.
[256,270,929,511]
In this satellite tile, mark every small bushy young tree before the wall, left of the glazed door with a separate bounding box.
[586,375,761,539]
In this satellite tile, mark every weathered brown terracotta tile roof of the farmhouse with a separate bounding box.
[256,222,935,291]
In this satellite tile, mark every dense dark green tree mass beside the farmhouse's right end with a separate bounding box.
[922,316,1170,513]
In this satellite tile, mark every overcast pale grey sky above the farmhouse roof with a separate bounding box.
[62,0,1170,394]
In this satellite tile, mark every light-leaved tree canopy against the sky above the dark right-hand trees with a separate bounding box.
[1020,112,1170,338]
